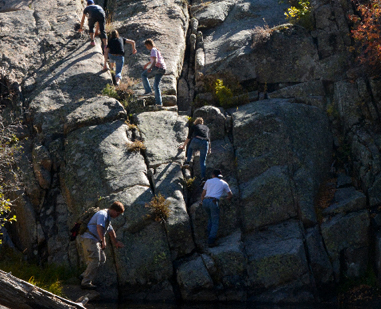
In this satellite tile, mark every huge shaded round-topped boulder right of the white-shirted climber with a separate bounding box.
[232,99,332,230]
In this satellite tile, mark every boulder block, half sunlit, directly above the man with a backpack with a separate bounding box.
[61,121,149,214]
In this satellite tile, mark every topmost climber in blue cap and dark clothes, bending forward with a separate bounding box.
[78,0,107,46]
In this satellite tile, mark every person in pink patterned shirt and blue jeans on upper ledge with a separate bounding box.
[142,39,166,105]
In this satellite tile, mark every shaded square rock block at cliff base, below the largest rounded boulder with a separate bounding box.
[244,221,313,301]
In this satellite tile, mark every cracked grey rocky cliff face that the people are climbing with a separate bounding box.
[0,0,381,303]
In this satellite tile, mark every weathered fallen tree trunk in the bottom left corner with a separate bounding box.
[0,270,85,309]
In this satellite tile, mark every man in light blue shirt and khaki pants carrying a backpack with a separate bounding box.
[81,202,124,290]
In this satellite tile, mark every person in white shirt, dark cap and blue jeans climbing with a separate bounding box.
[201,170,233,247]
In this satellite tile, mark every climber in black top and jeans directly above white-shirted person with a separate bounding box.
[179,117,212,185]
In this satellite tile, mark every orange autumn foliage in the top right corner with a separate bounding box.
[349,0,381,67]
